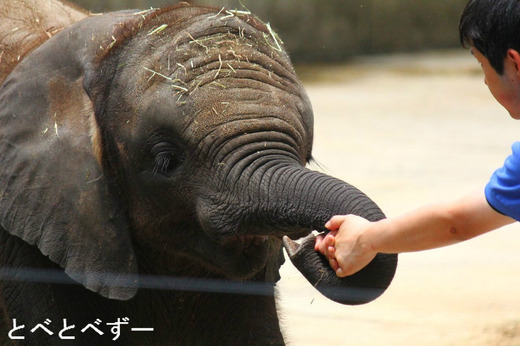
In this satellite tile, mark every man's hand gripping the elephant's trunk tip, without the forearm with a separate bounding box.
[315,215,377,277]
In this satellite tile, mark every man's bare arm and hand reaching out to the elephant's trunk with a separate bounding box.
[315,192,515,276]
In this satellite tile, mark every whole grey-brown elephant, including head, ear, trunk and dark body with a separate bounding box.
[0,0,397,345]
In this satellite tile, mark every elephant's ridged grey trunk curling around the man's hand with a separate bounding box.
[197,160,397,304]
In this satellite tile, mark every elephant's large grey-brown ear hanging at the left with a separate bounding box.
[0,13,145,300]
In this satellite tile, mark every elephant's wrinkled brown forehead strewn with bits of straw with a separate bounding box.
[103,6,312,166]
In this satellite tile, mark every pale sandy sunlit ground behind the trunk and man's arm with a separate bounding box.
[278,50,520,346]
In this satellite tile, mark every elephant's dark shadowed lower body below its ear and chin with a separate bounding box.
[0,231,283,345]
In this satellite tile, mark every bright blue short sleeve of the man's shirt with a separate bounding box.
[484,142,520,221]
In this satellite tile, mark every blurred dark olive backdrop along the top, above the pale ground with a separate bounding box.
[68,0,466,63]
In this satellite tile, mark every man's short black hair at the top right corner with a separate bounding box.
[459,0,520,74]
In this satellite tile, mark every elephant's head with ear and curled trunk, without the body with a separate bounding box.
[0,4,396,304]
